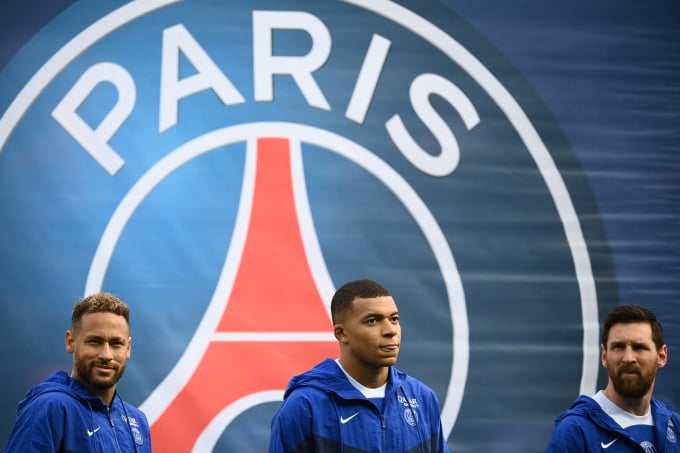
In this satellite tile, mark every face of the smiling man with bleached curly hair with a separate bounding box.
[66,313,131,402]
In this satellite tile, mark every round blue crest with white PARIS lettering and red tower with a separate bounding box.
[0,0,612,452]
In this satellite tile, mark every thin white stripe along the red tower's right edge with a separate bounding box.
[290,139,335,318]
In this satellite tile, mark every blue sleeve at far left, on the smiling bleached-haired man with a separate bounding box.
[4,395,66,453]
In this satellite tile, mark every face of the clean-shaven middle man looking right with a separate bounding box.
[340,296,401,368]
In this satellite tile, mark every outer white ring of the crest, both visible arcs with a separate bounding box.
[0,0,599,442]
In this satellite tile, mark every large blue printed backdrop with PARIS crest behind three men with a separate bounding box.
[0,0,680,452]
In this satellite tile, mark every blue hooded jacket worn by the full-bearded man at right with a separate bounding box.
[546,395,680,453]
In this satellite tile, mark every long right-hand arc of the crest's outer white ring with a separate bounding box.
[342,0,600,395]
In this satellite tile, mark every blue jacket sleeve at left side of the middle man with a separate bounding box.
[269,391,314,453]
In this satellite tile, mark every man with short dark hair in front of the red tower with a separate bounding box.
[269,280,448,453]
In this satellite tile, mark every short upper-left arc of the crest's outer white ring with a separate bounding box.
[0,0,181,153]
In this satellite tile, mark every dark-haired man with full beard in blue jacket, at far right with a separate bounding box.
[547,305,680,453]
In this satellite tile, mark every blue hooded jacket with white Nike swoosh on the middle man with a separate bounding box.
[269,359,448,453]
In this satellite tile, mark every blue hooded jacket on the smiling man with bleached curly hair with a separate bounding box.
[5,371,151,453]
